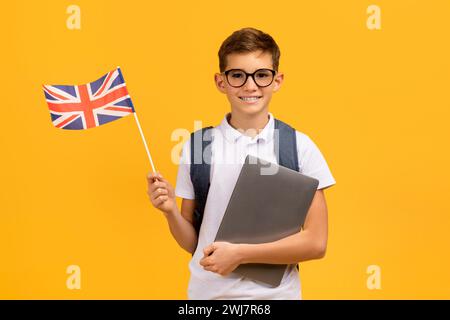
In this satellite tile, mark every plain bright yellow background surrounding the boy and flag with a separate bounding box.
[0,0,450,299]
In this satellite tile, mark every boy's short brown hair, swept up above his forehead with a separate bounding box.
[219,28,280,72]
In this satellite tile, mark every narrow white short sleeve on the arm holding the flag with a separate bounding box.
[175,139,195,200]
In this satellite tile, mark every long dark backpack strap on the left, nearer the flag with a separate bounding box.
[190,127,213,235]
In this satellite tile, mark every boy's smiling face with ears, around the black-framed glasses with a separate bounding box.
[214,51,284,115]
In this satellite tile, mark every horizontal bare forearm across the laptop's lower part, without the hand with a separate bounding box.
[239,231,326,264]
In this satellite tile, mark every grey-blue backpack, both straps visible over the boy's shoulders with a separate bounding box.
[190,119,299,235]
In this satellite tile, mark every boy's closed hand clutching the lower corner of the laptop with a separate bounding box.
[200,242,242,276]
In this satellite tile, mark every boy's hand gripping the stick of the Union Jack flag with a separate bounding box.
[147,172,177,215]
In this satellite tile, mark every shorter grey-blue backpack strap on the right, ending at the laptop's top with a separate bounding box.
[274,119,300,171]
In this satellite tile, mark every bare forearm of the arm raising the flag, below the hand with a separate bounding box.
[165,207,197,253]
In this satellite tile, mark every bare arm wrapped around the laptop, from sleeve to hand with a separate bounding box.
[200,190,328,275]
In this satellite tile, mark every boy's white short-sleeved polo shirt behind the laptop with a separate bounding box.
[175,113,336,300]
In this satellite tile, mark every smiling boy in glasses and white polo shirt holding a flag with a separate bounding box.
[148,28,335,299]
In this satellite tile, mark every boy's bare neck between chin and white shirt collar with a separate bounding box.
[227,110,270,138]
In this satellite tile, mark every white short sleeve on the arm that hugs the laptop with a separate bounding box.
[297,131,336,190]
